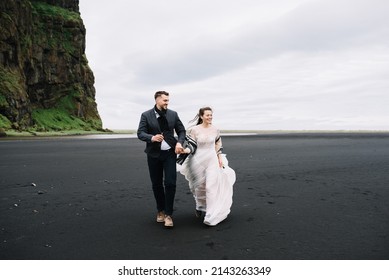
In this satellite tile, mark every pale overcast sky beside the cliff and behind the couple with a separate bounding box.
[80,0,389,130]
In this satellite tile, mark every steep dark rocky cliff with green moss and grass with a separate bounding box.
[0,0,102,135]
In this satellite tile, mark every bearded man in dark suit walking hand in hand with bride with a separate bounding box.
[137,91,185,228]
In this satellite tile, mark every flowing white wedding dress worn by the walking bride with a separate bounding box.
[178,125,236,226]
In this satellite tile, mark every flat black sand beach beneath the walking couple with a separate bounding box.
[0,133,389,260]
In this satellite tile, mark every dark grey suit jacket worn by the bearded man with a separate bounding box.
[137,108,186,157]
